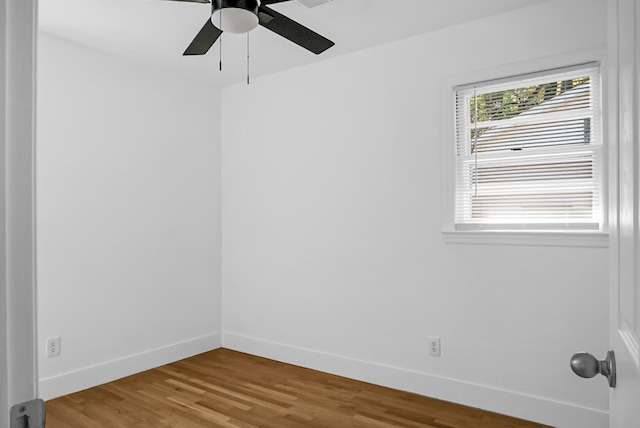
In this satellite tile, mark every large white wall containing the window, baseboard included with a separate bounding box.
[222,0,608,428]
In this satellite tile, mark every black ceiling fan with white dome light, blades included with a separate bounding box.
[174,0,335,55]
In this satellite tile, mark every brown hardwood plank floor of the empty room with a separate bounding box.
[46,349,544,428]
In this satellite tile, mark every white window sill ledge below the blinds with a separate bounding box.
[442,230,609,248]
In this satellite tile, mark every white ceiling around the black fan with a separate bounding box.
[39,0,547,85]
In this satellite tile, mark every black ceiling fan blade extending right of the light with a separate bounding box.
[258,5,335,55]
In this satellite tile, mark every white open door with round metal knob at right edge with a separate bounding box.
[608,0,640,428]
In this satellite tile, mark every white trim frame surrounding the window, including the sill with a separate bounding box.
[441,49,609,248]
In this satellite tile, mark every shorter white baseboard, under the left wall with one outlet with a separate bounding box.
[39,333,222,401]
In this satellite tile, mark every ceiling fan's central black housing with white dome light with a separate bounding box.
[211,0,259,34]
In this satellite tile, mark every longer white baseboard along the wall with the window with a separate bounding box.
[222,333,609,428]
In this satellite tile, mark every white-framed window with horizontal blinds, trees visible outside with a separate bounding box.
[455,63,603,231]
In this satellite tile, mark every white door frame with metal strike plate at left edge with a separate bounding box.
[0,0,41,428]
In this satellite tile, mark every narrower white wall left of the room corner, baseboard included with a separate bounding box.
[37,34,221,399]
